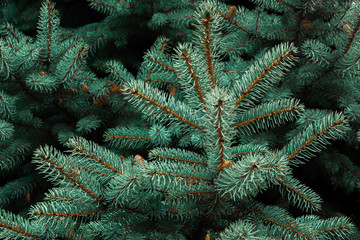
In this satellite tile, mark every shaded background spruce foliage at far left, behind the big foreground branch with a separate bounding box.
[0,1,114,212]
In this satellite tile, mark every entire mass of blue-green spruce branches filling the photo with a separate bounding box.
[0,0,360,240]
